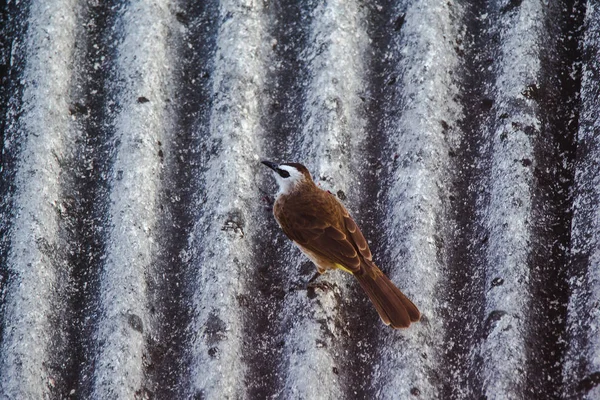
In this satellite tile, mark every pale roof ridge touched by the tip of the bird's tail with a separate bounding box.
[375,1,462,399]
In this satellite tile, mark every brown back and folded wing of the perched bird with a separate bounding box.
[275,189,371,272]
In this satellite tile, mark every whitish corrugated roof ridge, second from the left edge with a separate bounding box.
[92,0,171,399]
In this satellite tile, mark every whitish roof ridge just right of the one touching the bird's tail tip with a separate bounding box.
[477,0,544,399]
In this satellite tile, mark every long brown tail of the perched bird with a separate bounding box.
[354,261,421,328]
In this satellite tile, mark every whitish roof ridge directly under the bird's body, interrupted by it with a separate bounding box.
[284,0,376,399]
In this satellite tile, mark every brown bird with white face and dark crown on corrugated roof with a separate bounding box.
[261,160,421,329]
